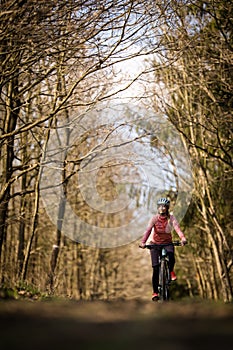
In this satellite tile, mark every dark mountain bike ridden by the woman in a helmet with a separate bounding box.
[145,241,182,302]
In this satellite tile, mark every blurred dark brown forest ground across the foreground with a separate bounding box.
[0,300,233,350]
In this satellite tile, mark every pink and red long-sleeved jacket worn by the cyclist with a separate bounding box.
[142,214,185,244]
